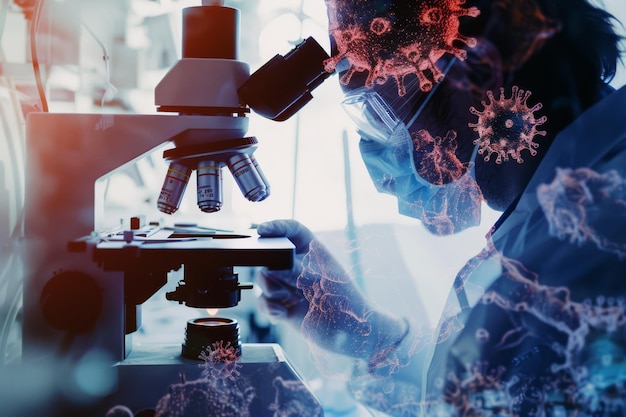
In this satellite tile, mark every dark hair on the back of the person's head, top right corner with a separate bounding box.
[461,0,622,127]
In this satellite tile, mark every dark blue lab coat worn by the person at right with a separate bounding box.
[423,83,626,416]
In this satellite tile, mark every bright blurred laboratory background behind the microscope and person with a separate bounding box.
[0,0,626,417]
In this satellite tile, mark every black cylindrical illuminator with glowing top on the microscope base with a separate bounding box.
[182,317,241,359]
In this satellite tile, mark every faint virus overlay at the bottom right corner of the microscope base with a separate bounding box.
[269,377,322,417]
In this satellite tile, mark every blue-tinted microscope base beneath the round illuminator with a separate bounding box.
[97,344,323,417]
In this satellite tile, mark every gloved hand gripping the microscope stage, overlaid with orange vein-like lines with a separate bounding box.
[257,220,408,369]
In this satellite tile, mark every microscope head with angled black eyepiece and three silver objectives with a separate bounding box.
[155,0,330,218]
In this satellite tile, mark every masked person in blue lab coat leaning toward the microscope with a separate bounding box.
[258,0,626,416]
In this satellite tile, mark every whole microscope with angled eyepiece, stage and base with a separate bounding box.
[23,1,330,417]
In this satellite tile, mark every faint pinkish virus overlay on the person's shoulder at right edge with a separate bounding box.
[537,168,626,258]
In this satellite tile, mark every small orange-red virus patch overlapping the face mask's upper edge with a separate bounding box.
[412,129,466,185]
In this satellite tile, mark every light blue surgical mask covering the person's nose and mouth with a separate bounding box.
[359,117,483,235]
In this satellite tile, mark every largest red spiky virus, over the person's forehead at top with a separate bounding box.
[324,0,480,96]
